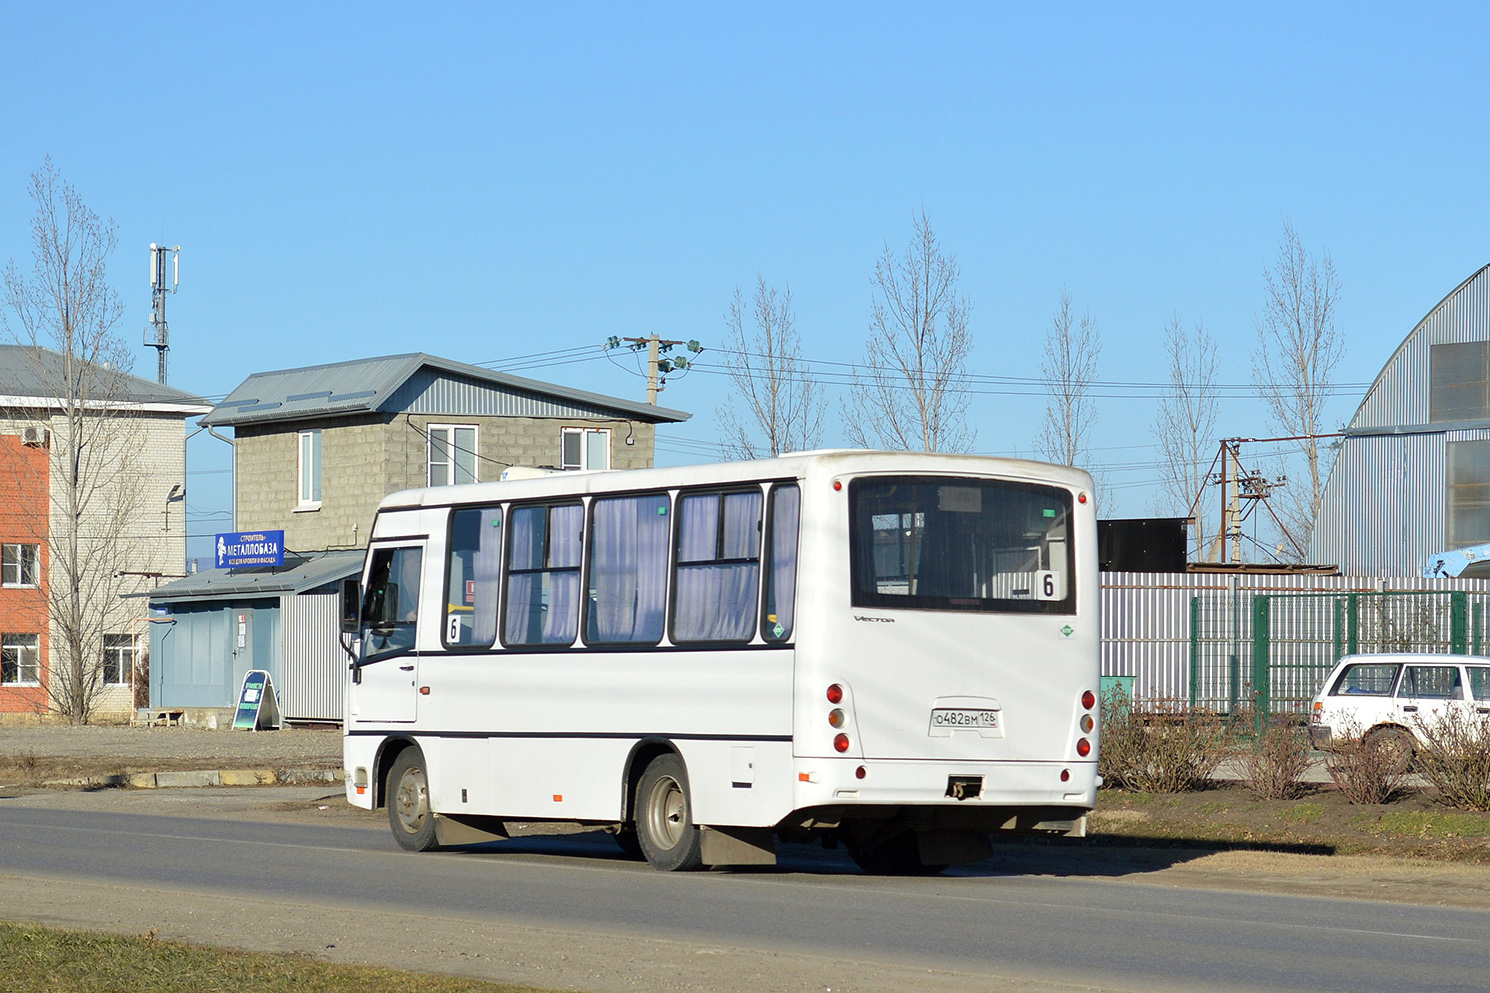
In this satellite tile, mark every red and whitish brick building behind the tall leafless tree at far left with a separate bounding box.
[0,346,212,719]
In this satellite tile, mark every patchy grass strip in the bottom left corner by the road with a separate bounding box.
[0,923,554,993]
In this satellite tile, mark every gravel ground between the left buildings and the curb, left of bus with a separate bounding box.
[0,725,341,775]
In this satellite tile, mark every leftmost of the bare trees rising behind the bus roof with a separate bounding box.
[718,276,827,459]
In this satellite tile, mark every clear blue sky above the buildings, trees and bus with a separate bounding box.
[0,3,1490,557]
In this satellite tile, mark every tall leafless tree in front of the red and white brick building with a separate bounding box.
[0,158,143,723]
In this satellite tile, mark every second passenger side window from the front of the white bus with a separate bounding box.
[502,504,584,646]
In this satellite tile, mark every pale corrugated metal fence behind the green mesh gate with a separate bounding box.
[1101,573,1490,708]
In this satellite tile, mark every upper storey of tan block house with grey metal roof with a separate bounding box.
[203,353,688,552]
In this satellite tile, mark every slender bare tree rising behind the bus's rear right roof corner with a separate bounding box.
[1036,289,1107,502]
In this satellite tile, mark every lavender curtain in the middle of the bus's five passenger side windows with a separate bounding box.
[584,494,668,644]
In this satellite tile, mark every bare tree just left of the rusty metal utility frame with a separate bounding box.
[1153,315,1217,540]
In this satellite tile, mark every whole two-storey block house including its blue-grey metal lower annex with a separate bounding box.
[149,353,688,726]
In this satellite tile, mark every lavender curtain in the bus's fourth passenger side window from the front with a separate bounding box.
[673,491,761,641]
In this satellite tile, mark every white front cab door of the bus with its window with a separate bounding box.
[352,546,423,723]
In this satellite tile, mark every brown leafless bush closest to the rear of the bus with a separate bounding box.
[1097,695,1228,793]
